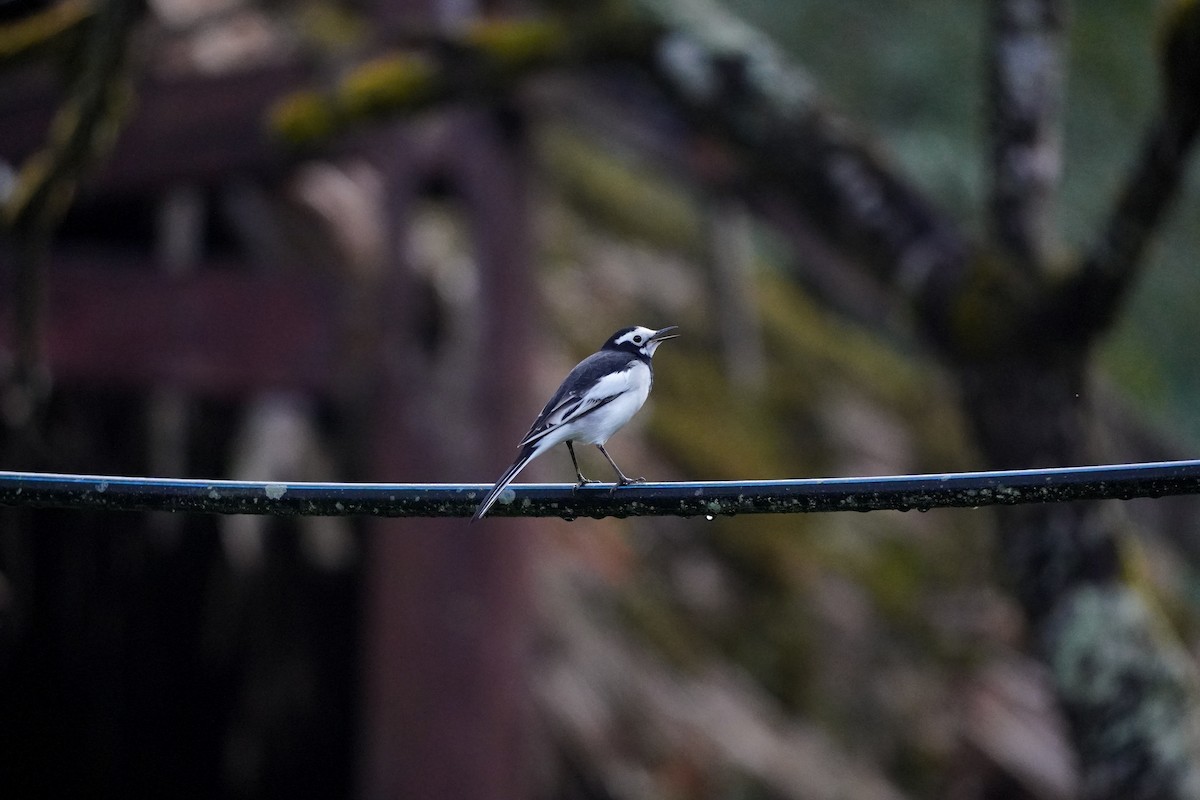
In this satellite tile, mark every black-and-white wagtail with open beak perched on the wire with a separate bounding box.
[472,325,678,522]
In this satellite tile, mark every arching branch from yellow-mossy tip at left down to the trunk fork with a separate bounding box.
[271,0,968,343]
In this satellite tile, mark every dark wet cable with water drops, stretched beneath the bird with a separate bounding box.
[0,461,1200,519]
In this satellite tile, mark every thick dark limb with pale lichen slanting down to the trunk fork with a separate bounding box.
[600,0,970,343]
